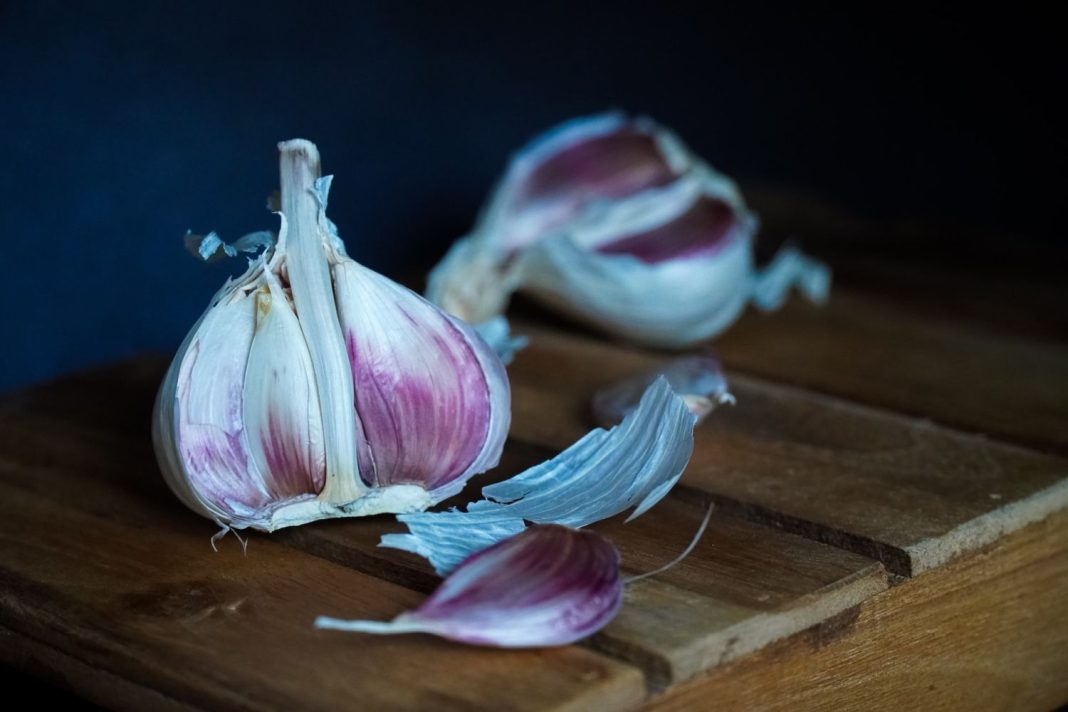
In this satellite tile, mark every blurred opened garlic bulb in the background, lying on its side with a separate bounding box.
[426,112,830,347]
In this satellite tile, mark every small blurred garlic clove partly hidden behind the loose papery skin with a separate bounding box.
[592,353,735,427]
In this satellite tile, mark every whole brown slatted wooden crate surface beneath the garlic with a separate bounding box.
[0,223,1068,710]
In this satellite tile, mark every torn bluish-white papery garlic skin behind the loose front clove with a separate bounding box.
[380,378,694,575]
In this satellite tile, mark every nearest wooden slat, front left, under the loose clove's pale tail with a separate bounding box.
[0,399,645,710]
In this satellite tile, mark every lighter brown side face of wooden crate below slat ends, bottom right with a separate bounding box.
[648,512,1068,712]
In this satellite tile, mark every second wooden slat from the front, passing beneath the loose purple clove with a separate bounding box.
[280,484,888,689]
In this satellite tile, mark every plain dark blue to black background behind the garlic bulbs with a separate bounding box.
[0,1,1066,390]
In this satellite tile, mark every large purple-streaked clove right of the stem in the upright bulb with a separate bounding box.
[334,260,508,500]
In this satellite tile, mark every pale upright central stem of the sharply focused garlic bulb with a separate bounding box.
[278,139,367,504]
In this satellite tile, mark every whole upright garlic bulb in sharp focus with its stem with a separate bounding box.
[154,140,509,532]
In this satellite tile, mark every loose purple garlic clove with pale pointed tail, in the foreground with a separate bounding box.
[315,525,623,648]
